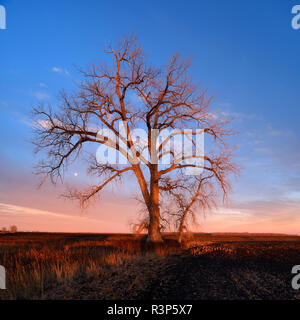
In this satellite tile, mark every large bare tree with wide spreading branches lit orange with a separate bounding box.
[33,37,235,242]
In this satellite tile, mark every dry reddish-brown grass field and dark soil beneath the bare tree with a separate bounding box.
[0,233,300,300]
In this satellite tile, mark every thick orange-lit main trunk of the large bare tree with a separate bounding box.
[147,165,163,243]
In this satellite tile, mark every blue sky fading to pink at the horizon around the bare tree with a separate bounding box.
[0,0,300,233]
